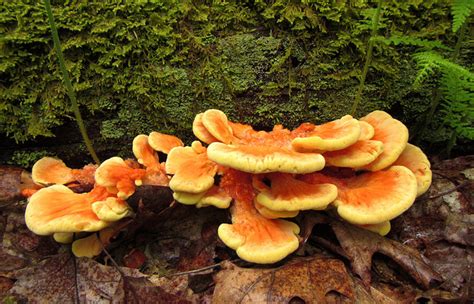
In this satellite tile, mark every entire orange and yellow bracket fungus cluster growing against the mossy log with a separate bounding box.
[25,109,431,264]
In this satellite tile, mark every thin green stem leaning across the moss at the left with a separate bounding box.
[44,0,100,164]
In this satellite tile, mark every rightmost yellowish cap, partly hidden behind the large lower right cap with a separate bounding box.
[393,144,432,196]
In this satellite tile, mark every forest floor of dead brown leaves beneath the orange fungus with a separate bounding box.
[0,156,474,303]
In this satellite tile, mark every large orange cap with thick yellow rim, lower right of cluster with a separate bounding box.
[301,166,417,225]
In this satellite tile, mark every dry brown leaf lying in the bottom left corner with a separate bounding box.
[9,255,193,303]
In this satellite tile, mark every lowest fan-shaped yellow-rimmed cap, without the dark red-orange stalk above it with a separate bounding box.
[217,201,299,264]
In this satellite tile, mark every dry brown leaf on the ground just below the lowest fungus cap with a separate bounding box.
[212,258,354,303]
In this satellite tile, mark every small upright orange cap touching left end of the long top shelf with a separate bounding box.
[202,109,234,144]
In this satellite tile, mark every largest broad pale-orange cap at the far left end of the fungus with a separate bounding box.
[25,185,110,235]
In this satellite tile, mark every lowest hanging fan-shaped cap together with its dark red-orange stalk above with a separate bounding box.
[218,170,299,264]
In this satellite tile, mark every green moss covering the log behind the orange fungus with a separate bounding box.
[0,0,462,166]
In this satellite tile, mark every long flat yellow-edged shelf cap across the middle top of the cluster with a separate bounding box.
[207,142,325,173]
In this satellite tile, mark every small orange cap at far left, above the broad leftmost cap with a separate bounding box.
[31,157,75,185]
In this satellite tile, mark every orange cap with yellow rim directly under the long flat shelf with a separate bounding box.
[255,173,337,211]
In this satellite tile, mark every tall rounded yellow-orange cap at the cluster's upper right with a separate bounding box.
[360,111,408,171]
